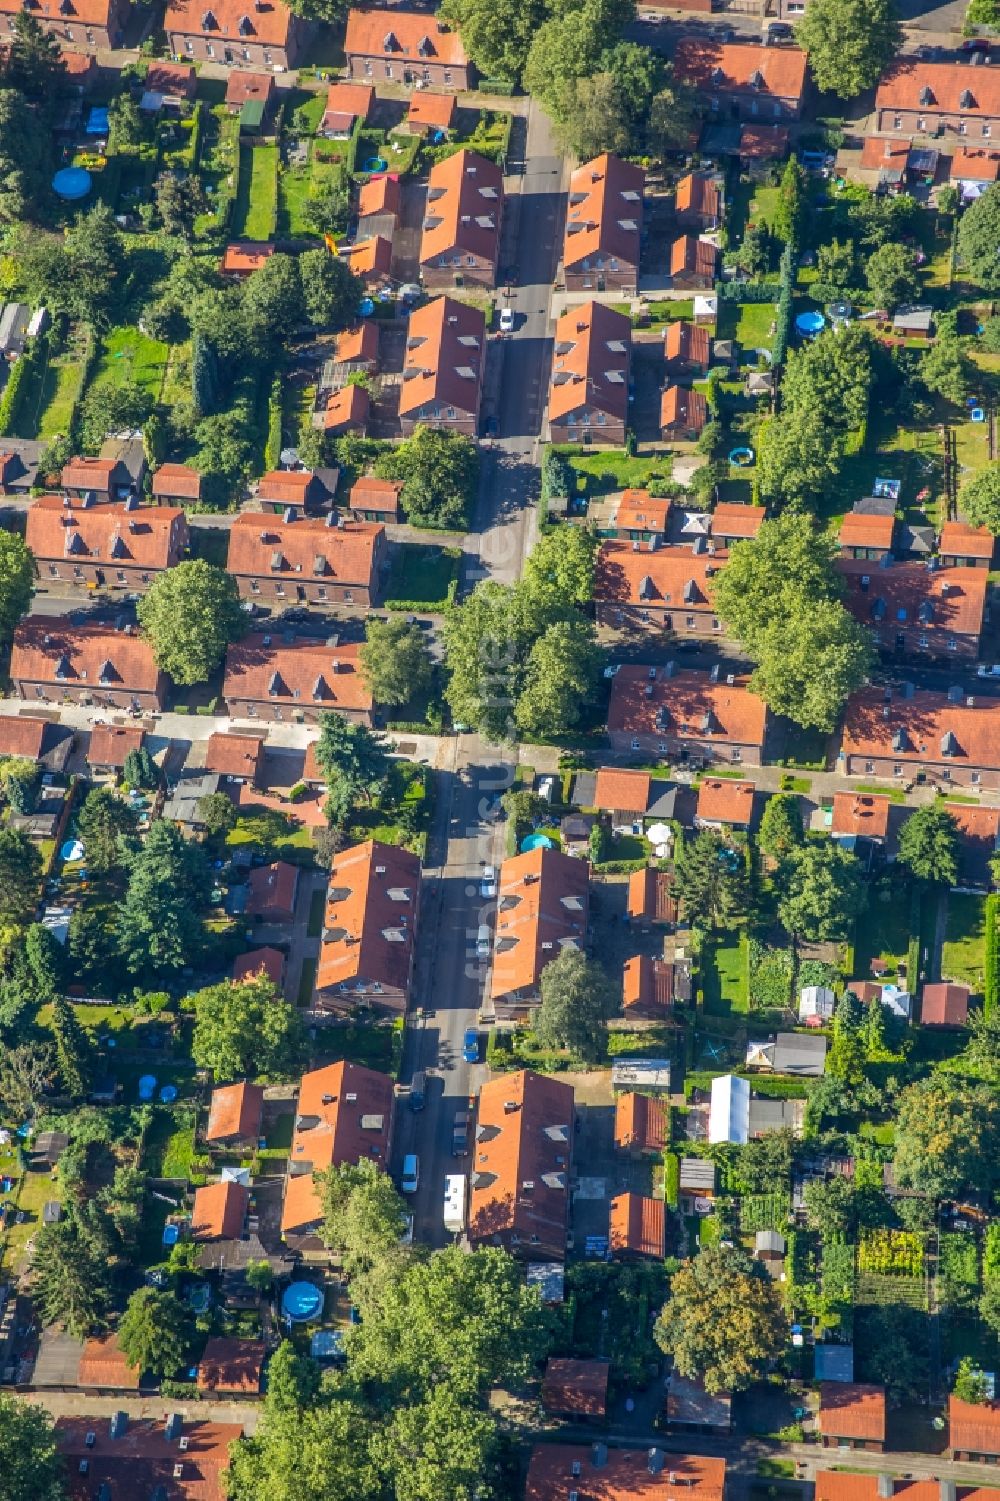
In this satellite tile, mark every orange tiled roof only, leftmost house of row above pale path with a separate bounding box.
[11,615,165,693]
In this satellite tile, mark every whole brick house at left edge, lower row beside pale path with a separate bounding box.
[11,615,167,713]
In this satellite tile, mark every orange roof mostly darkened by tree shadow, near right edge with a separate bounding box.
[835,558,988,636]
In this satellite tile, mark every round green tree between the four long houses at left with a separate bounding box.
[137,558,248,683]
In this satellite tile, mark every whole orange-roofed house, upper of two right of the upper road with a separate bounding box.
[563,152,646,297]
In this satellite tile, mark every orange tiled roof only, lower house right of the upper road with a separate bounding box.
[548,302,632,422]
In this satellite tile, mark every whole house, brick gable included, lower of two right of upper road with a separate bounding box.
[548,302,632,447]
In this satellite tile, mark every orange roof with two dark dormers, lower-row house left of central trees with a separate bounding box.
[222,635,372,713]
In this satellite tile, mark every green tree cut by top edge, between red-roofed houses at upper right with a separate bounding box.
[796,0,902,99]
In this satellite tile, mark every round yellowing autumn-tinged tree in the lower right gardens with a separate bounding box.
[655,1246,788,1391]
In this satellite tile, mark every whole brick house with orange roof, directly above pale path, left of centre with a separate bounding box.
[222,633,372,725]
